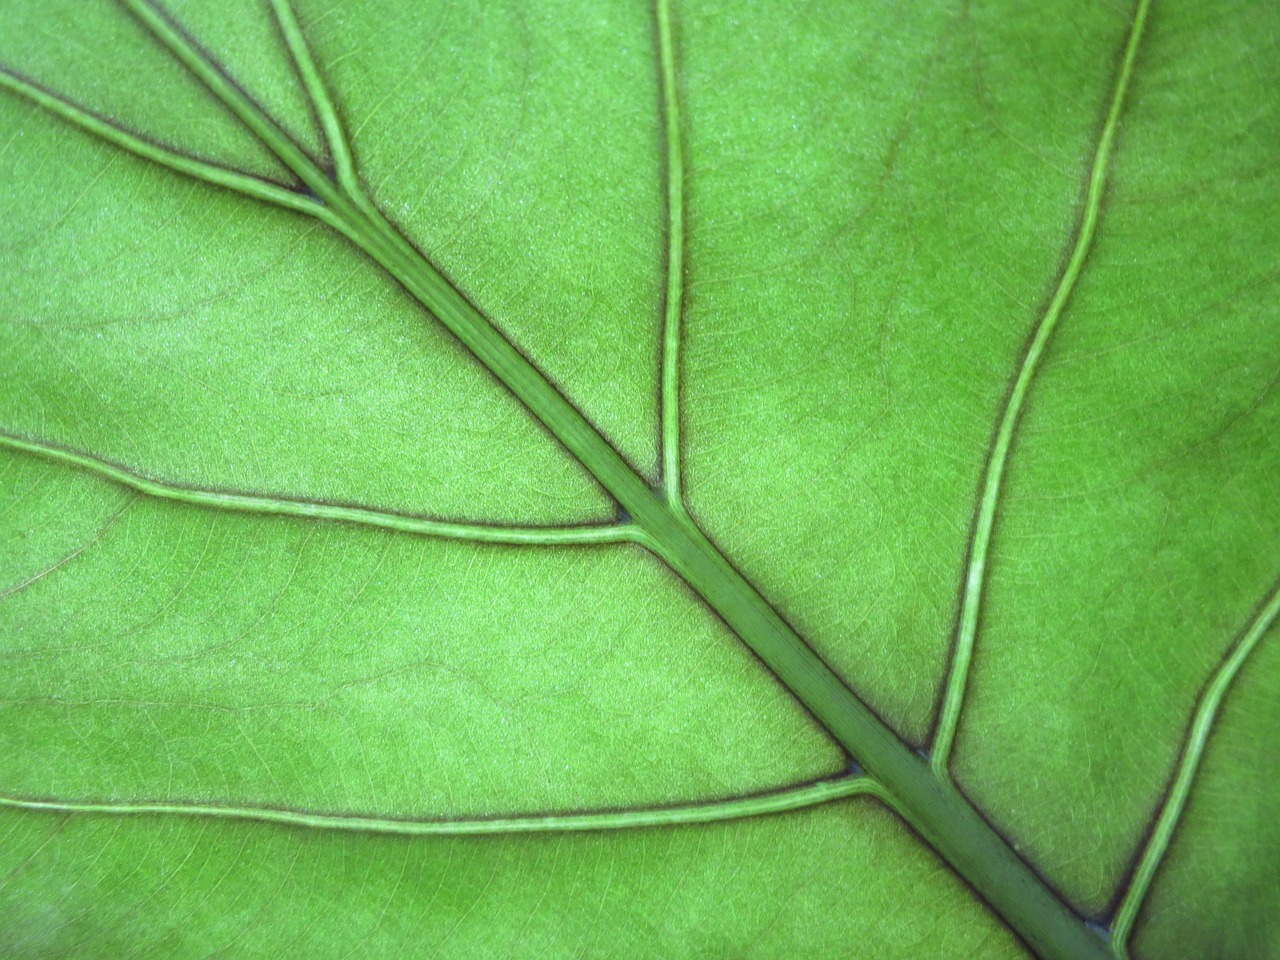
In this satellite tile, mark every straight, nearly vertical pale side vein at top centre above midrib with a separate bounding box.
[654,0,685,506]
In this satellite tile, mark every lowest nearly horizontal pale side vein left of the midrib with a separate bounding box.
[0,776,883,837]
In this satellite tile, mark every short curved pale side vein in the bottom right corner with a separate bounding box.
[1111,584,1280,960]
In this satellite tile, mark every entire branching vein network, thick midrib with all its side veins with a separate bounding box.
[0,0,1280,960]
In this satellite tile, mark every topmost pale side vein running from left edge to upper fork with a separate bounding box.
[0,68,323,216]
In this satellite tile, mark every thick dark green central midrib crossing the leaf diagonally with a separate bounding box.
[0,0,1131,960]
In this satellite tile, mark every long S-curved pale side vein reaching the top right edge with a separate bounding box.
[931,0,1151,777]
